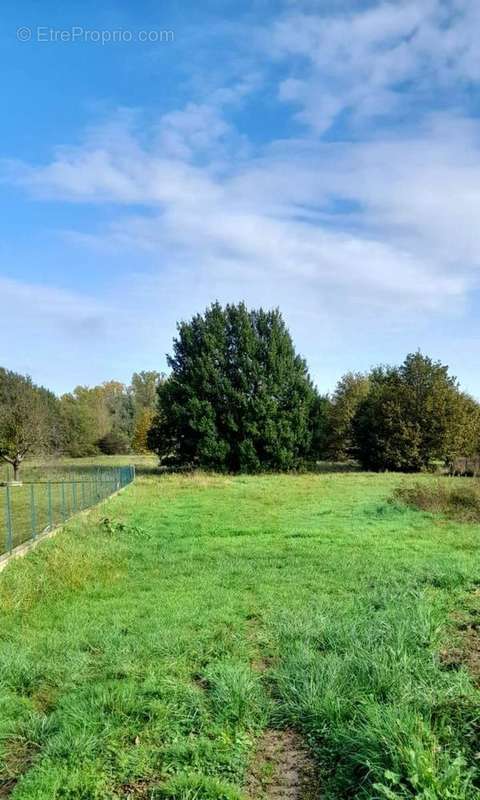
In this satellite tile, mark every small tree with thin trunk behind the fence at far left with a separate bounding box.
[0,368,48,481]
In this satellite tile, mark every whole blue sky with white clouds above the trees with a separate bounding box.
[0,0,480,397]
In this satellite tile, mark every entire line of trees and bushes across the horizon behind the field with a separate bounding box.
[0,303,480,472]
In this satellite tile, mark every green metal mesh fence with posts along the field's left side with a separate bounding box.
[0,466,135,554]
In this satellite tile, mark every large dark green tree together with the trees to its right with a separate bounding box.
[149,303,480,472]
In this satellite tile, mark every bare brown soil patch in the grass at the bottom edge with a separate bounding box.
[246,730,320,800]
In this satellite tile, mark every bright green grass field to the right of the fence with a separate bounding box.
[0,473,480,800]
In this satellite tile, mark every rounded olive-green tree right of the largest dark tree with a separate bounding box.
[353,353,460,472]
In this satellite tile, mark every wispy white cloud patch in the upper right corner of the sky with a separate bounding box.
[265,0,480,133]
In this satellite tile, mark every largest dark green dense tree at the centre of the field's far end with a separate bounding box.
[150,303,315,472]
